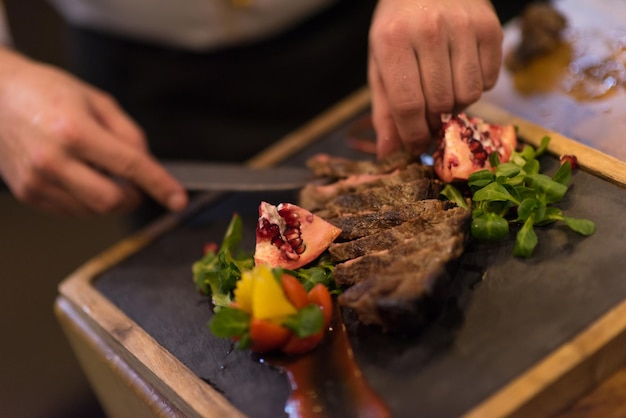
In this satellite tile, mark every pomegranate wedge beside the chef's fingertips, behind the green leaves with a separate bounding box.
[433,113,517,183]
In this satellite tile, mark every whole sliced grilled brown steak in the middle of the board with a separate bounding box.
[300,153,471,331]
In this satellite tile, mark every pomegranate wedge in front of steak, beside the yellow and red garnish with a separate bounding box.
[254,202,341,270]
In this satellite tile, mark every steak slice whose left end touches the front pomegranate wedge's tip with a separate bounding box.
[326,199,456,241]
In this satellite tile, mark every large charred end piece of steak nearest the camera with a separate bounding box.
[335,234,465,331]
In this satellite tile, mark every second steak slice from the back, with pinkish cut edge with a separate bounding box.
[299,163,434,210]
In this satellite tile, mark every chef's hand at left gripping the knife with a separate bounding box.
[0,48,187,215]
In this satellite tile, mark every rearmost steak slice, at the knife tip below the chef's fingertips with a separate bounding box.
[306,152,414,178]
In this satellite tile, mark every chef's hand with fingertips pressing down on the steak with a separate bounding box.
[368,0,502,158]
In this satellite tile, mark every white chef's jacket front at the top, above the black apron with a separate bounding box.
[49,0,337,50]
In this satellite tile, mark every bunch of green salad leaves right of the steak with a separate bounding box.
[441,136,595,258]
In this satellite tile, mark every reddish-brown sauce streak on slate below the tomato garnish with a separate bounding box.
[262,307,391,418]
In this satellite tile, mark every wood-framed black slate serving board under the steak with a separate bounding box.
[57,85,626,418]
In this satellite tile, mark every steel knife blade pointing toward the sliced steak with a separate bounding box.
[162,161,313,192]
